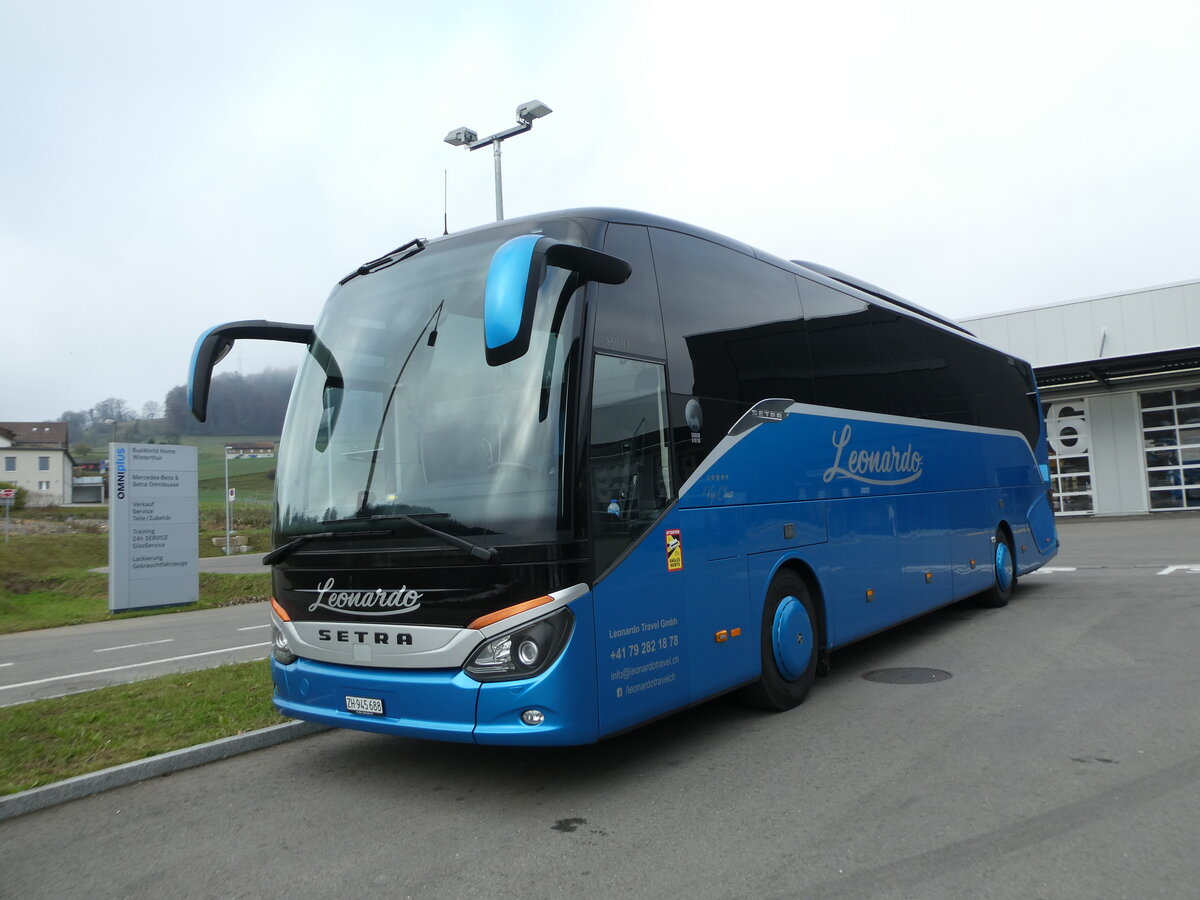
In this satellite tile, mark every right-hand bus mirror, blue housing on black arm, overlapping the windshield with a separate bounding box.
[484,234,632,366]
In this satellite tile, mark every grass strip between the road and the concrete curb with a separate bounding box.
[0,660,287,794]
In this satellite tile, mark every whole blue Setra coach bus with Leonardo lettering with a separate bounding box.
[190,209,1057,744]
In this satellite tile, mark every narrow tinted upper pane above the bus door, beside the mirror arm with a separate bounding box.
[595,224,666,359]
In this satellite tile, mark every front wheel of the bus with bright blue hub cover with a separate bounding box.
[742,572,820,710]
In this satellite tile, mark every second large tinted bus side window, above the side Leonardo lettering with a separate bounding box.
[798,278,893,413]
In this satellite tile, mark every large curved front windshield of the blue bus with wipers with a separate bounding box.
[276,222,582,545]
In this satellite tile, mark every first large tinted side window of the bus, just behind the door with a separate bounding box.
[650,229,811,404]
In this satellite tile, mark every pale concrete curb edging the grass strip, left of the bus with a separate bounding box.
[0,721,329,822]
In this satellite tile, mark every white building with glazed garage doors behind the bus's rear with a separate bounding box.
[962,281,1200,515]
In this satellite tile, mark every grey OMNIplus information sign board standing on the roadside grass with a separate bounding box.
[108,444,200,612]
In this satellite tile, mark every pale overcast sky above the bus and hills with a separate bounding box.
[0,0,1200,420]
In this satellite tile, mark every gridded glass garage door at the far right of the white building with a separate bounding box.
[1138,388,1200,510]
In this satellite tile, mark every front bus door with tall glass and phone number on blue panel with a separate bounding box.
[588,354,689,734]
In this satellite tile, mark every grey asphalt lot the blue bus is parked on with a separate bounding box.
[0,517,1200,900]
